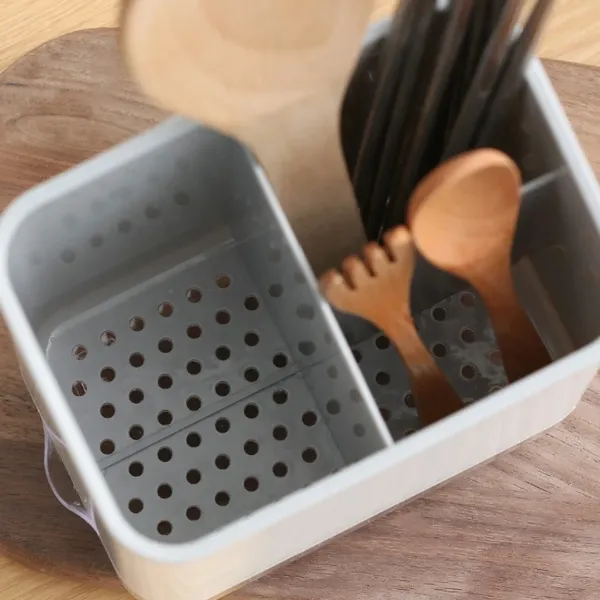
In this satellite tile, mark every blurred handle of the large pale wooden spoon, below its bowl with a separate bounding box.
[243,90,366,276]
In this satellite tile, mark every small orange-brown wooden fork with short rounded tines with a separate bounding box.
[321,226,462,426]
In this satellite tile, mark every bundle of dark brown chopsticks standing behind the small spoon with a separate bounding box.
[352,0,553,239]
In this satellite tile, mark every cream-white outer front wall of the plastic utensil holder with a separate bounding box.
[100,367,595,600]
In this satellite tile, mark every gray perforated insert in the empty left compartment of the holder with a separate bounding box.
[47,232,392,543]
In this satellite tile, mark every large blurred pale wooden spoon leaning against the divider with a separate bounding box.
[121,0,373,274]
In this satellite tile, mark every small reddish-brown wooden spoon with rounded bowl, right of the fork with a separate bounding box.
[407,149,550,381]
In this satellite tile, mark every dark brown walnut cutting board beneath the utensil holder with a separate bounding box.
[0,29,600,600]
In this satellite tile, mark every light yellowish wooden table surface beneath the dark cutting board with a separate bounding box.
[0,0,600,600]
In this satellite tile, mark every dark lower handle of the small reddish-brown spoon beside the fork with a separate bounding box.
[474,261,550,383]
